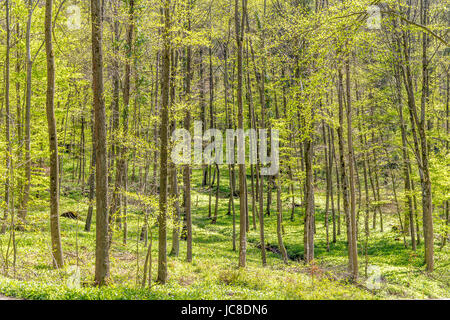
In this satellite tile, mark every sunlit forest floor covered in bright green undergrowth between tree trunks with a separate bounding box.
[0,170,450,299]
